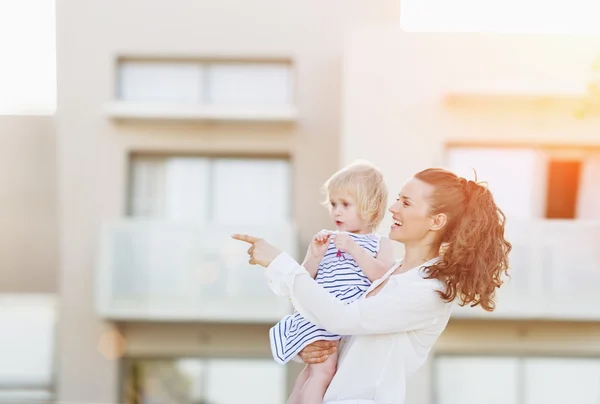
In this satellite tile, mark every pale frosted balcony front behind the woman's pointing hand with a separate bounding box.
[96,219,297,323]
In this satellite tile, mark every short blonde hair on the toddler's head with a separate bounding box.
[323,160,388,230]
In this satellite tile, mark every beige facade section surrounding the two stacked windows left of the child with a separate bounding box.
[57,0,398,402]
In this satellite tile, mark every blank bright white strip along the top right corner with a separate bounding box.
[400,0,600,34]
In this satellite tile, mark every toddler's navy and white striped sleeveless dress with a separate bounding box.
[269,232,379,364]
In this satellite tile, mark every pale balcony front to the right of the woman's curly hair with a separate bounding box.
[453,220,600,321]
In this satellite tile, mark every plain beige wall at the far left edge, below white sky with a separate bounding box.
[0,116,58,293]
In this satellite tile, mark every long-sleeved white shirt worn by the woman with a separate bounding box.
[265,253,452,404]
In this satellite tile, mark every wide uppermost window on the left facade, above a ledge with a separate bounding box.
[118,60,293,107]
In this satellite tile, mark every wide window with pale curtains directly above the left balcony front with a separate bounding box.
[130,156,291,225]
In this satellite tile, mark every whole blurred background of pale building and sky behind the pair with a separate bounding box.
[0,0,600,404]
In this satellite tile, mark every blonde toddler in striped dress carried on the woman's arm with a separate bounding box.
[269,162,394,404]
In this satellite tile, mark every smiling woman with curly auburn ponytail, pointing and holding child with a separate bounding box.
[234,169,511,404]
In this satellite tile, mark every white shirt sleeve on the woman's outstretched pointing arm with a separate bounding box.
[266,253,448,335]
